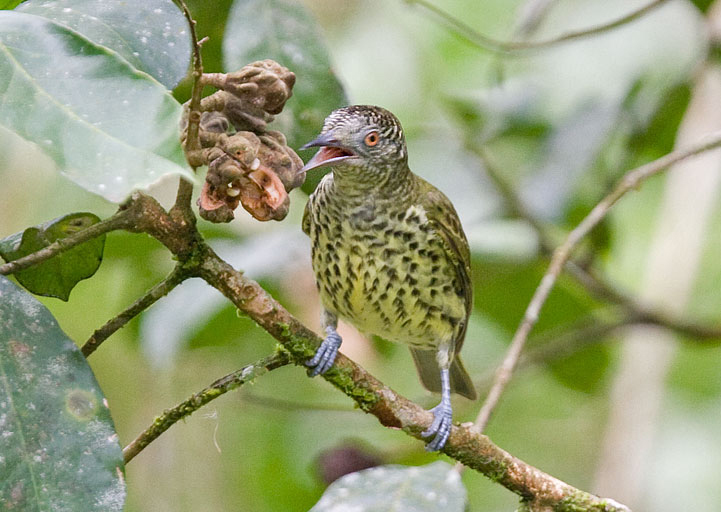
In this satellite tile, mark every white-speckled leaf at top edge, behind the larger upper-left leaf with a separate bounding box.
[17,0,190,89]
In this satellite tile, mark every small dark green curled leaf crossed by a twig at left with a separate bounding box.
[0,213,105,301]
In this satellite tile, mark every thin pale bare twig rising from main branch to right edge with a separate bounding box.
[476,132,721,431]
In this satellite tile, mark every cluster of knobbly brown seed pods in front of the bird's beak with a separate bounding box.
[188,60,305,222]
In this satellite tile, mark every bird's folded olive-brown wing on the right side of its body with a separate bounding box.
[419,180,473,352]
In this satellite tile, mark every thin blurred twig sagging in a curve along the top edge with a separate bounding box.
[404,0,668,53]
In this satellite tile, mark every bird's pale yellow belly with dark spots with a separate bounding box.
[313,214,465,349]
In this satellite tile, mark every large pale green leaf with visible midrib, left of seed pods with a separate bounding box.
[0,10,193,202]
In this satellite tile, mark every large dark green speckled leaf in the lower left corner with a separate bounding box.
[0,276,125,512]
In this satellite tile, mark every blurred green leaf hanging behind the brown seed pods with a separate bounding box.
[223,0,348,154]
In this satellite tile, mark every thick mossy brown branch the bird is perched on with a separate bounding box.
[190,242,628,512]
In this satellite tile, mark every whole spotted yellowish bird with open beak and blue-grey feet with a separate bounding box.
[301,105,476,451]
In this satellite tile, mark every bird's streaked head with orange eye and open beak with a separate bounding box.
[301,105,408,176]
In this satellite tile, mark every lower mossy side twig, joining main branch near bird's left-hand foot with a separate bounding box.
[123,351,290,464]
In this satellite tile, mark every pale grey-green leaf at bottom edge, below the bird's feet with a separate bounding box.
[310,461,466,512]
